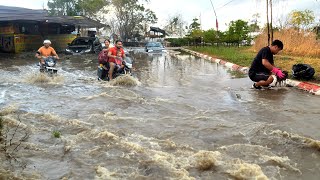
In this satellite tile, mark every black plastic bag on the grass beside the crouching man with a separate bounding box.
[292,64,315,80]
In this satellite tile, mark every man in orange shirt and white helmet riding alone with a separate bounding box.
[35,39,59,69]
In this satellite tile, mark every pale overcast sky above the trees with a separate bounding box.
[0,0,320,31]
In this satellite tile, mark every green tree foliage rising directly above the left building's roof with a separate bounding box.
[47,0,108,17]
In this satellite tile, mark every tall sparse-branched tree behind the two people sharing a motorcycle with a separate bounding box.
[112,0,157,40]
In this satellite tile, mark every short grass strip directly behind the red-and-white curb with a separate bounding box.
[189,46,320,84]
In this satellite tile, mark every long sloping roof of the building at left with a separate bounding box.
[0,5,105,28]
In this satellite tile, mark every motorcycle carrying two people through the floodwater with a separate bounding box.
[97,55,133,81]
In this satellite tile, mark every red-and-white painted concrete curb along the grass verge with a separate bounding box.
[175,48,320,95]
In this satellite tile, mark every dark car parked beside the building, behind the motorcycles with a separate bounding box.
[65,37,102,55]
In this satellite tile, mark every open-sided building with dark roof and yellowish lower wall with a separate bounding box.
[0,6,104,53]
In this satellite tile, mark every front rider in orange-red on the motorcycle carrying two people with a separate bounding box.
[108,40,126,80]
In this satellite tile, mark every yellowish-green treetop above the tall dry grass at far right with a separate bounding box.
[289,9,315,29]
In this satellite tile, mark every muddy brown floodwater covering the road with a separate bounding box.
[0,49,320,180]
